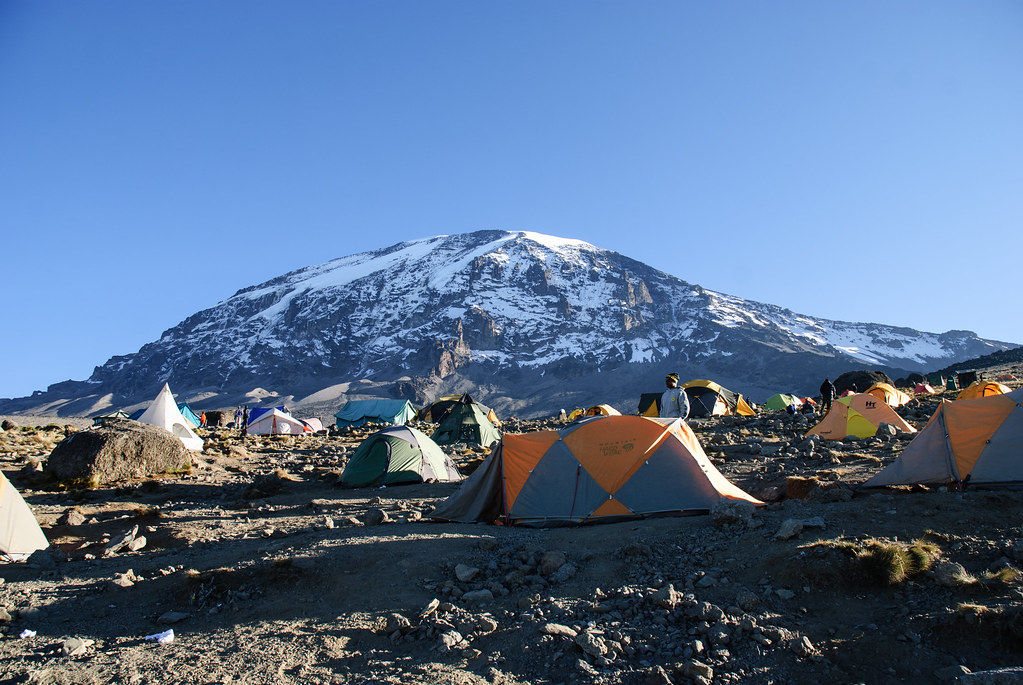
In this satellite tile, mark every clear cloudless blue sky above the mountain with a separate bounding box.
[0,0,1023,397]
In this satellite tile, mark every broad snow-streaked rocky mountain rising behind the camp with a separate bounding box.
[6,231,1016,415]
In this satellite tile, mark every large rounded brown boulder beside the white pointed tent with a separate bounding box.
[46,420,191,488]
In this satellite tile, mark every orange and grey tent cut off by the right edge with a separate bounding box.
[863,389,1023,488]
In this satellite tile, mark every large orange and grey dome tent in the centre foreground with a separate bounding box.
[430,416,763,526]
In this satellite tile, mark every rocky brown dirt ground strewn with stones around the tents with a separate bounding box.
[0,369,1023,685]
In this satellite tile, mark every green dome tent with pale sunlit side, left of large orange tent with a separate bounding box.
[338,425,461,488]
